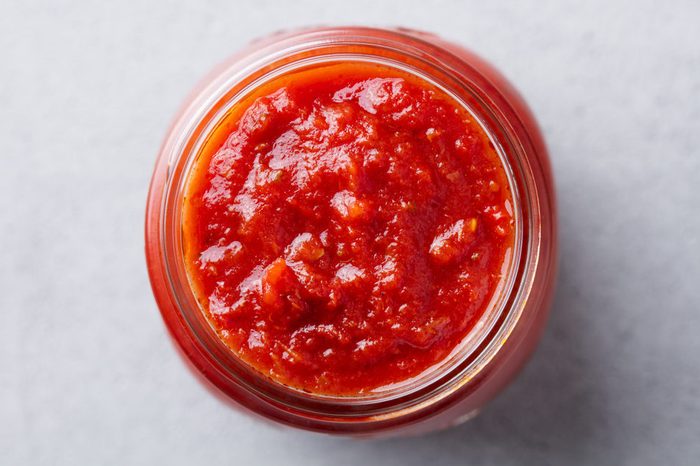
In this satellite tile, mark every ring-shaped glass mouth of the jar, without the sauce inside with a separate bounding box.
[154,29,533,418]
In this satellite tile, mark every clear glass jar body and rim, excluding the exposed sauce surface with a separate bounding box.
[146,27,557,436]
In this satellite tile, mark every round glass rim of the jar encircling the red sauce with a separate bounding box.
[145,28,539,430]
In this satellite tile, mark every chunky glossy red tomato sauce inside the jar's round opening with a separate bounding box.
[183,63,514,396]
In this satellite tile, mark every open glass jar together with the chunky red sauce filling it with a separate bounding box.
[146,28,556,436]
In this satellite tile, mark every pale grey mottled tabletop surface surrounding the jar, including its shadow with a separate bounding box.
[0,0,700,466]
